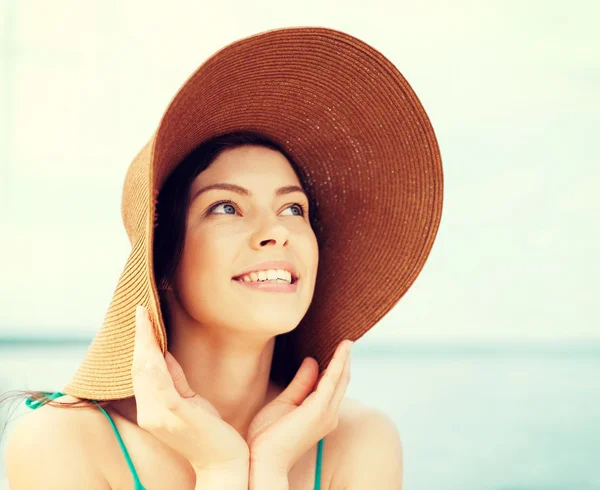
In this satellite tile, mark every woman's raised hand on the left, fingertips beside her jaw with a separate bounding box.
[131,306,250,473]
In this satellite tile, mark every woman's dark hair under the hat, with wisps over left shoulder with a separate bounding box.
[0,131,319,432]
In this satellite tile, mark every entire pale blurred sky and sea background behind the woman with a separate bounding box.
[0,0,600,490]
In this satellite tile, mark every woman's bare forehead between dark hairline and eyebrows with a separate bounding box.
[192,145,300,191]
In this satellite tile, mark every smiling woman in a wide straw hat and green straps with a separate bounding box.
[7,28,442,490]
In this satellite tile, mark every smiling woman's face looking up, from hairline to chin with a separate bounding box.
[174,146,319,336]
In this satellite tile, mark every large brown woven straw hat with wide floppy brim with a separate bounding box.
[63,27,443,400]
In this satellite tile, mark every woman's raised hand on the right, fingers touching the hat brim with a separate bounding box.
[246,340,353,475]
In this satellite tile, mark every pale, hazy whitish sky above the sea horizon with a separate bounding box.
[0,0,600,340]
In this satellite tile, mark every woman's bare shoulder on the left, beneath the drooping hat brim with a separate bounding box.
[5,397,110,490]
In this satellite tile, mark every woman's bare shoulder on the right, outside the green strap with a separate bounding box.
[325,397,403,490]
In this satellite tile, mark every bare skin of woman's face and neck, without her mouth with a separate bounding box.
[152,146,319,436]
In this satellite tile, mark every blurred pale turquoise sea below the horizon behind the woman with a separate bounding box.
[0,340,600,490]
